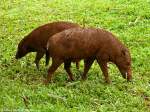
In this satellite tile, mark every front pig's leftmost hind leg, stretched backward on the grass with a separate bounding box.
[44,58,63,84]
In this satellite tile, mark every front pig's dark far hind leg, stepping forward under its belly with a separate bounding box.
[64,60,74,81]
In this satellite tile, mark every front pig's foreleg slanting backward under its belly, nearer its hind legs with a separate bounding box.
[82,58,94,80]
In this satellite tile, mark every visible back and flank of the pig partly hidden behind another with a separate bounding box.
[26,21,79,47]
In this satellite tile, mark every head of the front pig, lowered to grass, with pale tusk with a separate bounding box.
[115,48,132,81]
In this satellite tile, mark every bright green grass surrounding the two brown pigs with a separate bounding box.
[0,0,150,112]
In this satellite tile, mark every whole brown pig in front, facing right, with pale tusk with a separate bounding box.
[45,28,131,83]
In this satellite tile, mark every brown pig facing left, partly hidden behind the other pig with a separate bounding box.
[16,21,79,68]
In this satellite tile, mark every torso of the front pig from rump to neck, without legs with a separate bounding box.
[48,28,124,58]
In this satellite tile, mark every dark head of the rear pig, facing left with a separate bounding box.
[15,39,29,59]
